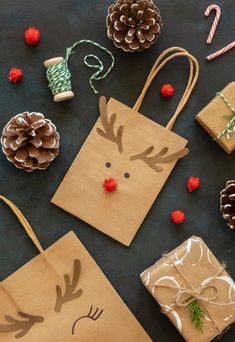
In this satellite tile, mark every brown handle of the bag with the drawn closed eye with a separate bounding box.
[0,195,44,254]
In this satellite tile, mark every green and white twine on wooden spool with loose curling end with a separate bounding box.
[47,39,115,95]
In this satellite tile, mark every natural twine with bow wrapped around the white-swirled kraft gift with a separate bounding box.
[155,254,235,334]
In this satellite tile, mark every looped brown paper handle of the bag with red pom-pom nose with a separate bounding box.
[133,47,199,130]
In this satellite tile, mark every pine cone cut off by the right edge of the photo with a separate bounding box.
[220,180,235,229]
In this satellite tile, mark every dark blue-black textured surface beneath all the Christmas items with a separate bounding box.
[0,0,235,342]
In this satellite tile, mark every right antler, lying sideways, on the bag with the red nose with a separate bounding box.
[130,146,189,172]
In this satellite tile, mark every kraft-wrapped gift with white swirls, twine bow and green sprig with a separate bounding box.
[141,236,235,342]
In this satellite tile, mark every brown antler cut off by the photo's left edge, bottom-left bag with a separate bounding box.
[0,312,44,338]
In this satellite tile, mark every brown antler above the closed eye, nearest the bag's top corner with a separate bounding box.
[55,259,82,312]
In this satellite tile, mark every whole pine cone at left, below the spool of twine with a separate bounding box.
[1,112,60,172]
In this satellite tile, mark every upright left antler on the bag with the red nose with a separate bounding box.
[97,96,123,153]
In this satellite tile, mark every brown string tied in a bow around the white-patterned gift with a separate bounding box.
[155,254,235,334]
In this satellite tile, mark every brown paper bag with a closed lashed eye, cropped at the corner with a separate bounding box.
[0,196,151,342]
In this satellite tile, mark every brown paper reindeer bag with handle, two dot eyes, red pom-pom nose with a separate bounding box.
[52,48,199,246]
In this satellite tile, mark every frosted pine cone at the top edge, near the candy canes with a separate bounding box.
[106,0,162,52]
